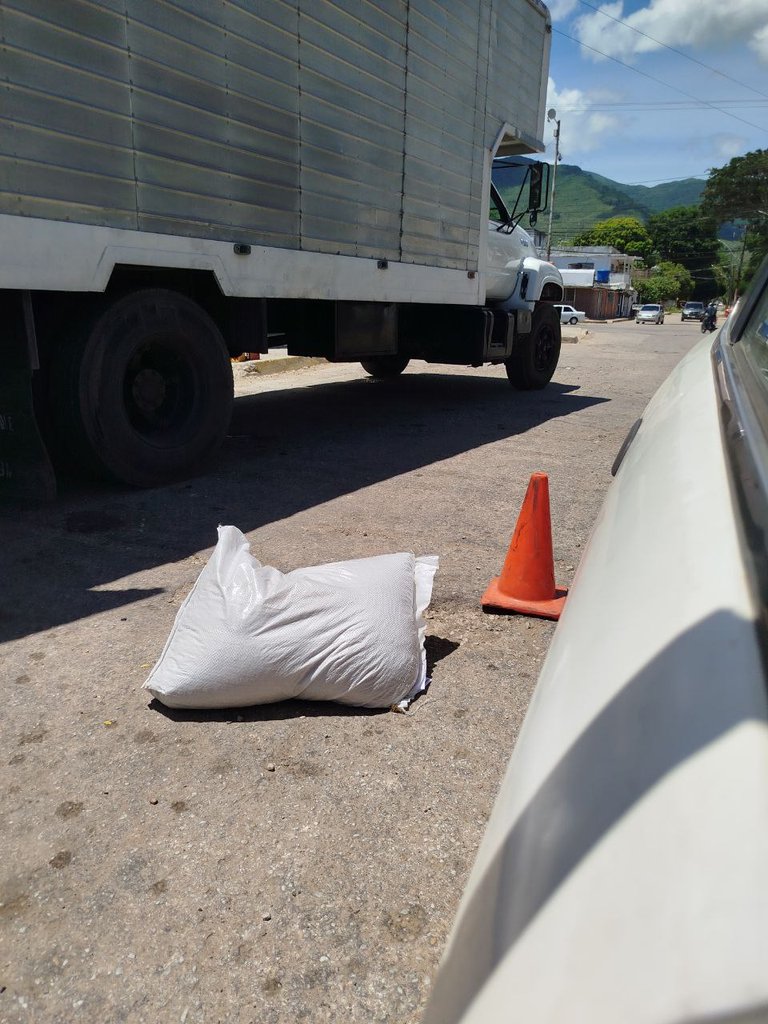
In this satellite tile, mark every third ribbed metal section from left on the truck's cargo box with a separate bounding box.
[299,0,407,259]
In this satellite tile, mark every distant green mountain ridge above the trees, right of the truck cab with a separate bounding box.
[539,164,705,245]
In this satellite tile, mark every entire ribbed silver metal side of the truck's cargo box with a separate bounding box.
[0,0,548,269]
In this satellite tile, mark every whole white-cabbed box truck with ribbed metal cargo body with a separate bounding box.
[0,0,563,498]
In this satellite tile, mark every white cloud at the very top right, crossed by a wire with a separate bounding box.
[574,0,768,63]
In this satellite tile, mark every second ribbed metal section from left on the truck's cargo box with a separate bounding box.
[126,0,299,248]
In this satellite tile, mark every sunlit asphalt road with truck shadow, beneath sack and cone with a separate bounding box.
[0,318,700,1024]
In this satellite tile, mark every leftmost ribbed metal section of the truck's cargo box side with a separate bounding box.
[0,0,136,227]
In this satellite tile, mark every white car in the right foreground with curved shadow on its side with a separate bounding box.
[425,261,768,1024]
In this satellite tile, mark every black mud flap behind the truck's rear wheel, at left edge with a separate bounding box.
[0,293,56,503]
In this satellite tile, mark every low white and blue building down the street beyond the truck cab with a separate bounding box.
[550,246,640,319]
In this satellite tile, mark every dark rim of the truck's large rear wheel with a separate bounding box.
[123,339,198,438]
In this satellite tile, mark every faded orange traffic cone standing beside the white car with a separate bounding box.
[481,473,567,618]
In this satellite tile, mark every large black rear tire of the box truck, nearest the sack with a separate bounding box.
[51,289,233,487]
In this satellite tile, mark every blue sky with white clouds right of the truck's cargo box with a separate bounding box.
[545,0,768,184]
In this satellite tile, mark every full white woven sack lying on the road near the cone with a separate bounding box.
[144,526,438,708]
